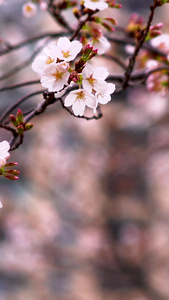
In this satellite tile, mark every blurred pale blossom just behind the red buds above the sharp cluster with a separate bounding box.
[89,35,110,55]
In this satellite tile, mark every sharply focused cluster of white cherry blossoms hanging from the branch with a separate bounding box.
[32,37,115,116]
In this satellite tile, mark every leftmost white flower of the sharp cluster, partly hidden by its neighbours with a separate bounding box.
[32,46,57,74]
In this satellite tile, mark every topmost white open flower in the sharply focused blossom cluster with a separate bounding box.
[55,37,82,61]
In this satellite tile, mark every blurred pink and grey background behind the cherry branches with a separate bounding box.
[0,0,169,300]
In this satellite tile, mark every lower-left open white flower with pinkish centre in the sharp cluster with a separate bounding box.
[41,62,69,92]
